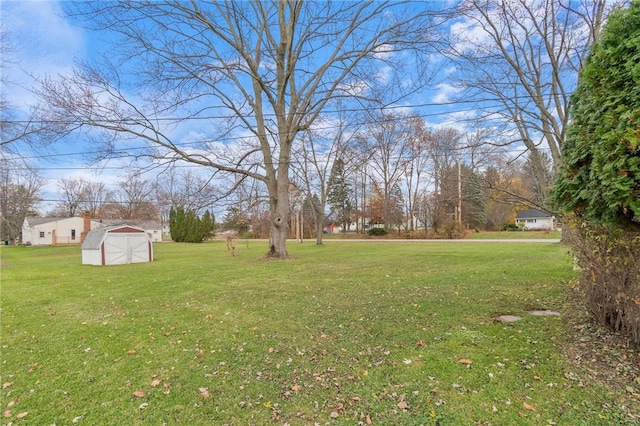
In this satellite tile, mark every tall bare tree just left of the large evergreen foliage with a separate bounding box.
[449,0,607,206]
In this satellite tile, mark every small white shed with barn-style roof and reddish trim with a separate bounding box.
[82,225,153,265]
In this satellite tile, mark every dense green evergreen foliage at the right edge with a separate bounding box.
[553,1,640,229]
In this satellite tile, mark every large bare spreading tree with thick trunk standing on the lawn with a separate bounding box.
[38,0,441,257]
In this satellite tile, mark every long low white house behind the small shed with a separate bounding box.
[22,215,162,246]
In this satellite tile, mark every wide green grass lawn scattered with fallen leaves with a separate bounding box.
[0,241,640,425]
